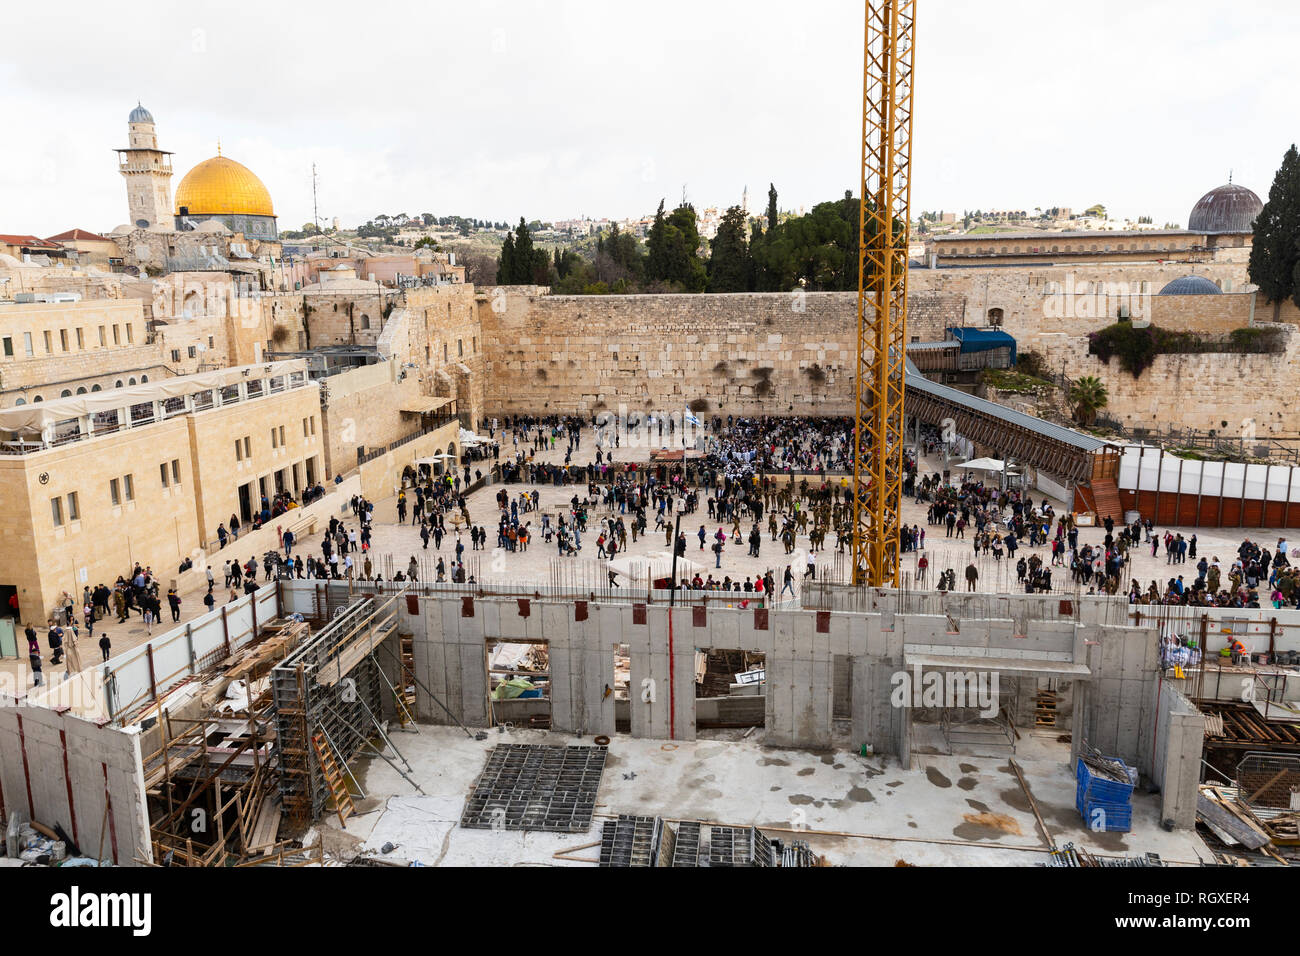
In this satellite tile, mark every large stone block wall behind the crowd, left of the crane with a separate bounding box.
[478,291,962,415]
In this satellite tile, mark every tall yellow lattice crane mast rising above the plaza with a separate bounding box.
[853,0,917,587]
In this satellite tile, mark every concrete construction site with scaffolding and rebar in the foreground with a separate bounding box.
[0,580,1300,866]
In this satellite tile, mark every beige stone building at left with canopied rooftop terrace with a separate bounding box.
[0,362,326,623]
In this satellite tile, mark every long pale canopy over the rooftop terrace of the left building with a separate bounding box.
[0,359,307,433]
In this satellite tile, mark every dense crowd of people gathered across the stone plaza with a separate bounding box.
[26,416,1300,680]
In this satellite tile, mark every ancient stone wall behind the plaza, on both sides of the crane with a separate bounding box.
[478,278,1300,437]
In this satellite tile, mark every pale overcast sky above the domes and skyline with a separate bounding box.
[0,0,1300,235]
